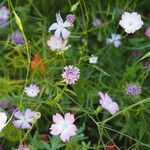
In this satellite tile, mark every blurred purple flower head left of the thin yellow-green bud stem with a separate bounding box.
[8,31,24,45]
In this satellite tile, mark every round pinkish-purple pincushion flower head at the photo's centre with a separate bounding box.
[62,66,80,84]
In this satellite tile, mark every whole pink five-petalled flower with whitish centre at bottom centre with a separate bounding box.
[50,113,77,142]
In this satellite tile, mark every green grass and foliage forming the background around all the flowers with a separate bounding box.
[0,0,150,150]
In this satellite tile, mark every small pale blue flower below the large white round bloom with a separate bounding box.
[106,33,121,48]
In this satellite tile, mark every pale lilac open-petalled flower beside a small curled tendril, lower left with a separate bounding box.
[13,108,36,129]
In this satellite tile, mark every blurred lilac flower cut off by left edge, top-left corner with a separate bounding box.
[0,6,10,27]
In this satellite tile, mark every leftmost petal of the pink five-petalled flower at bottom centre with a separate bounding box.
[50,124,62,135]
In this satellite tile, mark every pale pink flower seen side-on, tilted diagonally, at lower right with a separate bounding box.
[98,92,119,115]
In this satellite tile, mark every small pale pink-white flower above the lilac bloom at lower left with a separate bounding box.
[24,84,40,97]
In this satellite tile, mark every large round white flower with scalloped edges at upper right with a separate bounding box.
[119,12,143,33]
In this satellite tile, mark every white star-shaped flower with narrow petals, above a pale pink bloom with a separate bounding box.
[48,12,72,39]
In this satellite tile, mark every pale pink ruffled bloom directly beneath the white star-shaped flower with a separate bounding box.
[47,35,70,52]
